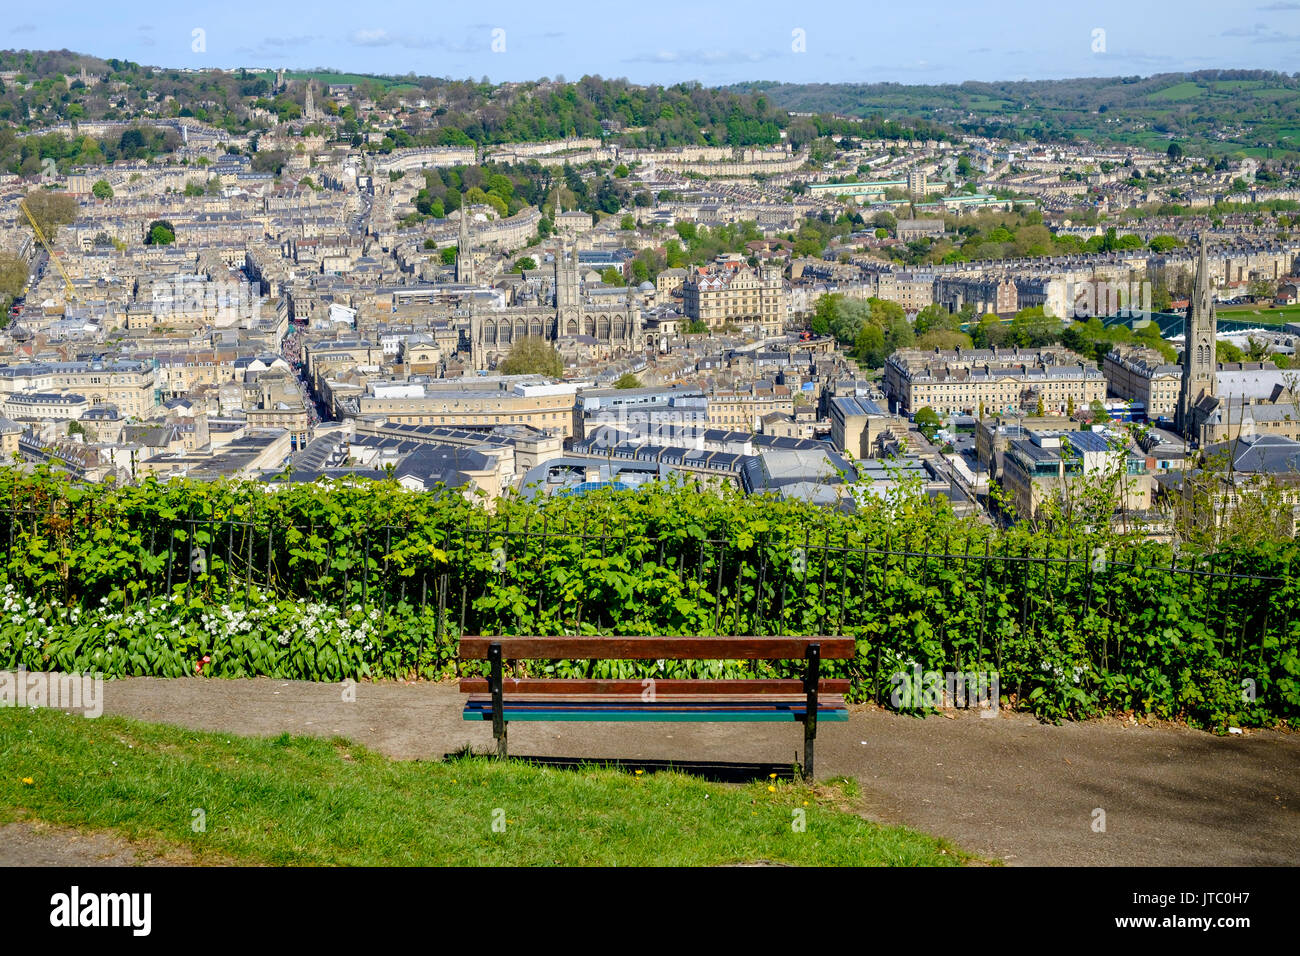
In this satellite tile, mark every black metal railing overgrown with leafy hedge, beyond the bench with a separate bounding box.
[0,501,1284,700]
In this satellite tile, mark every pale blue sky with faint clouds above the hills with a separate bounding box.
[10,0,1300,85]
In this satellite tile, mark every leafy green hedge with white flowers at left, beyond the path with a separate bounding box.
[0,470,1300,728]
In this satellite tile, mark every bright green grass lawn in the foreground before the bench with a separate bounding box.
[0,708,970,866]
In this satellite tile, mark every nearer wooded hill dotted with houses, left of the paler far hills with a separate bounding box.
[0,49,948,176]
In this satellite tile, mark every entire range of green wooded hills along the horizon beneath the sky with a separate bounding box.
[0,49,1300,164]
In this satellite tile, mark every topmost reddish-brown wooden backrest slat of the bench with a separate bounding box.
[460,636,857,661]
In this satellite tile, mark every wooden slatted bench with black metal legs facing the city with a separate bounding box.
[460,636,855,777]
